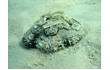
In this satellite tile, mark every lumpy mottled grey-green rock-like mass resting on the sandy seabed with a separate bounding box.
[22,11,85,52]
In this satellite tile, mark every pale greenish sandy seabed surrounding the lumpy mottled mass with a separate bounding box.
[8,0,101,69]
